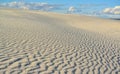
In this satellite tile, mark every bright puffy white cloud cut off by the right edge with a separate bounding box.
[103,6,120,15]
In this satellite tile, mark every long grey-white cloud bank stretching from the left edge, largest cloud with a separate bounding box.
[0,2,61,11]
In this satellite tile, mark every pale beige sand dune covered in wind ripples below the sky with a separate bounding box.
[0,8,120,74]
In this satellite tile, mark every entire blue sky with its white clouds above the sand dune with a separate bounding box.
[0,0,120,19]
